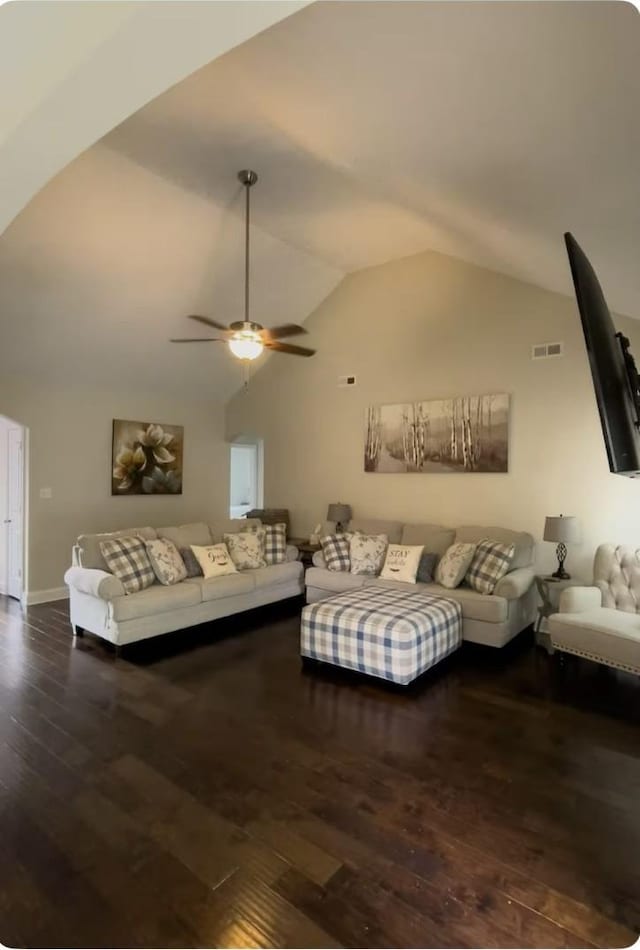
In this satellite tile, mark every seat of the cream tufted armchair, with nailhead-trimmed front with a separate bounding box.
[549,607,640,671]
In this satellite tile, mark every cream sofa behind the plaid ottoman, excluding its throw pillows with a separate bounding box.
[305,518,536,647]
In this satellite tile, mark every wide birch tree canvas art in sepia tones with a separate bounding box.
[364,393,509,473]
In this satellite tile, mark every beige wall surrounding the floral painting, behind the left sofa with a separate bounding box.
[0,376,229,594]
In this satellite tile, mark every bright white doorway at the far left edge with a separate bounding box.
[0,416,25,600]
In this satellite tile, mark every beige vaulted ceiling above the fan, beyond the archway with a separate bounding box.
[0,0,640,398]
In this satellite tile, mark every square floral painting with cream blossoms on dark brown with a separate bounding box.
[111,419,184,495]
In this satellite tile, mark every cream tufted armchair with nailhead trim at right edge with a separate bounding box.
[549,544,640,674]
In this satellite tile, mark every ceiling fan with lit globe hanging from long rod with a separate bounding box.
[170,169,315,360]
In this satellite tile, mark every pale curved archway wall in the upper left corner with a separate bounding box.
[0,0,305,232]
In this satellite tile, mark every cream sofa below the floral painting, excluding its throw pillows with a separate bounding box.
[64,519,304,646]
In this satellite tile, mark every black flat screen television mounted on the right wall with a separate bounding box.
[564,232,640,478]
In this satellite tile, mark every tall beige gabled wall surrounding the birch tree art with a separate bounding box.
[227,247,640,577]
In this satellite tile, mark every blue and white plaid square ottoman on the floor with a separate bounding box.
[300,584,462,686]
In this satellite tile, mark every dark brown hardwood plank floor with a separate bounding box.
[0,598,640,947]
